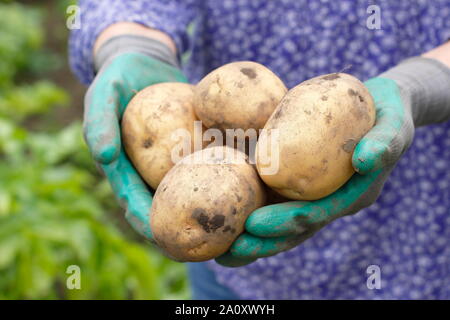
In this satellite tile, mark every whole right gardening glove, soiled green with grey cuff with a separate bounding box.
[217,57,450,267]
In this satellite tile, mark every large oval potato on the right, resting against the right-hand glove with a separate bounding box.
[256,73,375,200]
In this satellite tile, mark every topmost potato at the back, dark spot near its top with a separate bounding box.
[195,61,287,131]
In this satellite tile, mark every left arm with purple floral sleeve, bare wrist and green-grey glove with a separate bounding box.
[70,0,196,240]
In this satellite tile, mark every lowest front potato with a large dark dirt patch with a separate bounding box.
[151,146,265,261]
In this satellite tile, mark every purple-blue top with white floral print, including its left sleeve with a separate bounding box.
[70,0,450,299]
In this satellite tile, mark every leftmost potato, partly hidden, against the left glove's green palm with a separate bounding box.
[122,82,201,189]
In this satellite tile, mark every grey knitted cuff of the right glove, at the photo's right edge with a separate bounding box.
[379,57,450,127]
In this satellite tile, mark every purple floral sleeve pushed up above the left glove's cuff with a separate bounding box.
[69,0,195,84]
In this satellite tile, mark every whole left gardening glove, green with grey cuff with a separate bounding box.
[83,35,186,240]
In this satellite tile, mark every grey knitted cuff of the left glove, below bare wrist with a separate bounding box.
[94,34,180,72]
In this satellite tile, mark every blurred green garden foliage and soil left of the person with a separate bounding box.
[0,0,190,299]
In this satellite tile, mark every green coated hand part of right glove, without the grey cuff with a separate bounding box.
[216,78,414,267]
